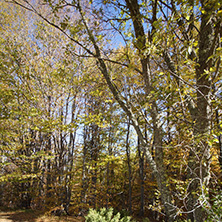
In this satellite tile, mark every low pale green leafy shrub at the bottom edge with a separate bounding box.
[85,208,131,222]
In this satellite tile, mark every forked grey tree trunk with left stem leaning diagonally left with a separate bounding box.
[78,0,175,219]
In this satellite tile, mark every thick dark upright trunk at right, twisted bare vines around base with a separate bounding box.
[188,0,215,222]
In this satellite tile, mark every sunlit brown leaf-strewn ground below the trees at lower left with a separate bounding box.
[0,210,84,222]
